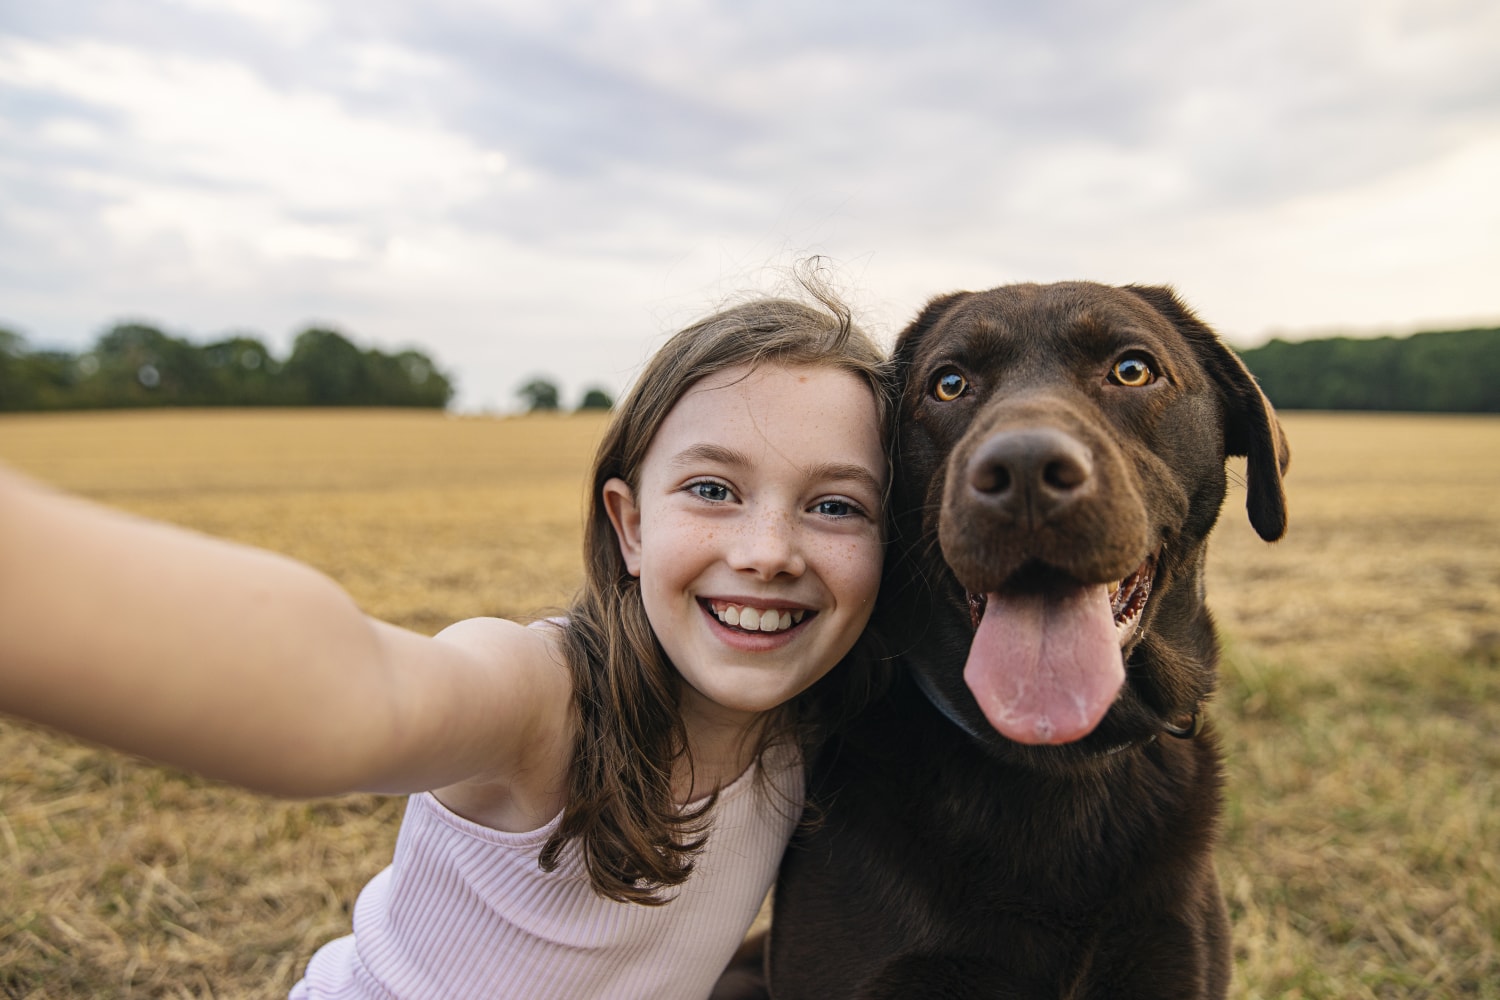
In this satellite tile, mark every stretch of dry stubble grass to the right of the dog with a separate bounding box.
[1209,414,1500,997]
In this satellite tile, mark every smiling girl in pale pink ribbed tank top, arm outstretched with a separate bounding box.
[0,300,888,1000]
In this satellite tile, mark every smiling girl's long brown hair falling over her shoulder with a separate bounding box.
[540,289,891,904]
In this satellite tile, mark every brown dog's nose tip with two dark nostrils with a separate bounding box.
[969,427,1094,525]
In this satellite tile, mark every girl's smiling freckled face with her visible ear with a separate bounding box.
[605,363,887,724]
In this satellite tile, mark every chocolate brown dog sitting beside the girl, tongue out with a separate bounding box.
[770,283,1287,1000]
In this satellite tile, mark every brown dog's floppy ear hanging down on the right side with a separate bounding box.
[1128,285,1292,541]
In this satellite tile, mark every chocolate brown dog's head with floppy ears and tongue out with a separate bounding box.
[881,282,1287,759]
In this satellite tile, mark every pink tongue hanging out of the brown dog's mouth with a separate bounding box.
[963,585,1125,744]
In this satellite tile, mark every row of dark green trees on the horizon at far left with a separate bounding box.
[0,324,453,411]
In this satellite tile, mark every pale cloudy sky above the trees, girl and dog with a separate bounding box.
[0,0,1500,409]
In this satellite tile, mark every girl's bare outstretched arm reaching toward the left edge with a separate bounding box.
[0,466,570,796]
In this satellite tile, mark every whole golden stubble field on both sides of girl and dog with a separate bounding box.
[0,411,1500,999]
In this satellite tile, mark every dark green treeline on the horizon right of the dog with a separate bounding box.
[1239,328,1500,414]
